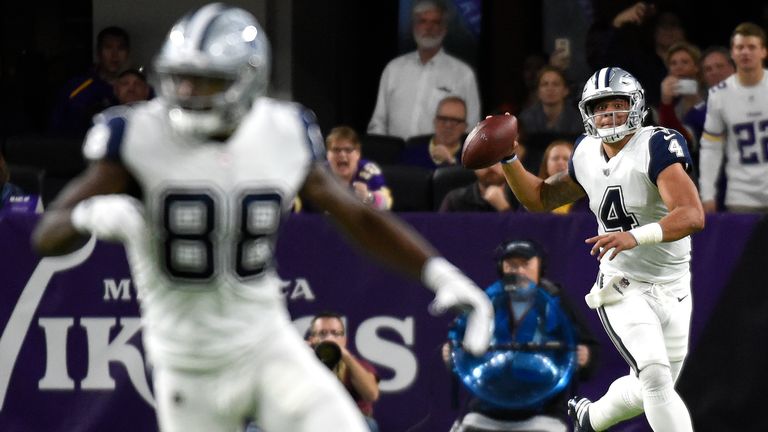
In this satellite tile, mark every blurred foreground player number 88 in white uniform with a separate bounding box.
[33,4,493,432]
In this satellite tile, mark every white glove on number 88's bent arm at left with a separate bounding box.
[71,194,146,242]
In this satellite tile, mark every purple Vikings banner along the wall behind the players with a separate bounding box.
[0,214,758,432]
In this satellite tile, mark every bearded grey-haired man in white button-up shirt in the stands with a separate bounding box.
[368,0,480,139]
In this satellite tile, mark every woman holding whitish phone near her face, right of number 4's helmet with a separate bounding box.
[657,42,707,147]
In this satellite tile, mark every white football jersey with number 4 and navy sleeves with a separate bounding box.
[569,127,691,283]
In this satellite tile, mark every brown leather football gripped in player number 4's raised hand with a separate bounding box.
[461,114,517,169]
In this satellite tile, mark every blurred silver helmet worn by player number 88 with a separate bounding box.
[154,3,270,136]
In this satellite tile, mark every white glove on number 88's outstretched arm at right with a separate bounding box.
[421,257,494,356]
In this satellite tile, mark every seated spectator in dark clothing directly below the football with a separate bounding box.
[438,163,520,212]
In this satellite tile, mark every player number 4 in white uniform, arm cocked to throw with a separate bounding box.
[502,68,704,432]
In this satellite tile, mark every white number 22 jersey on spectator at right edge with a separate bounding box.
[701,70,768,207]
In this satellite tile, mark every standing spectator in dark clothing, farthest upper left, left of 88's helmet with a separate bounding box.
[51,26,131,137]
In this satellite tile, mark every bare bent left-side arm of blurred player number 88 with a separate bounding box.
[32,161,130,255]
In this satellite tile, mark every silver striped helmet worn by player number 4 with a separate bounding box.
[579,67,647,142]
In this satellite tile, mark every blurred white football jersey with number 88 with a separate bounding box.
[84,98,322,369]
